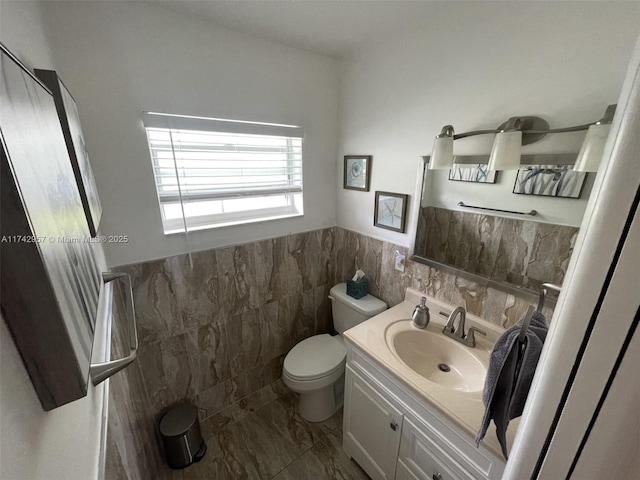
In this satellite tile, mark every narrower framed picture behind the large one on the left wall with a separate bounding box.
[35,69,102,237]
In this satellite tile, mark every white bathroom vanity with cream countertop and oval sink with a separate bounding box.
[343,289,517,480]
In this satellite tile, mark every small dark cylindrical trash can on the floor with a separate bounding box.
[160,403,207,470]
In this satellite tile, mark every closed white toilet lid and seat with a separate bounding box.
[284,333,347,382]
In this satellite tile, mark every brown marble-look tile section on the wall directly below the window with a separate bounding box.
[119,229,335,419]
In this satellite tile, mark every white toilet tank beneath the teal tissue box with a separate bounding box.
[329,283,387,335]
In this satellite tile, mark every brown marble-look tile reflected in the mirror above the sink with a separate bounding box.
[416,207,578,290]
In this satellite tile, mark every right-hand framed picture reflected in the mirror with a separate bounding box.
[513,165,586,198]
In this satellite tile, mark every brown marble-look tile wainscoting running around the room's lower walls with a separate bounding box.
[107,227,552,479]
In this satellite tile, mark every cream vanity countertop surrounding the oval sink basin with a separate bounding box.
[344,289,519,459]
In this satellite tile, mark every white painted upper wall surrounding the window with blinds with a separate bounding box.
[39,2,338,265]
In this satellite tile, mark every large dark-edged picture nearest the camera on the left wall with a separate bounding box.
[0,44,102,410]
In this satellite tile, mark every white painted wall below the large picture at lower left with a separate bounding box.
[0,318,107,480]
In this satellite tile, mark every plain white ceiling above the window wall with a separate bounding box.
[148,0,446,59]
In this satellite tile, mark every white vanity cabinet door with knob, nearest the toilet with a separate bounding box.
[344,366,403,480]
